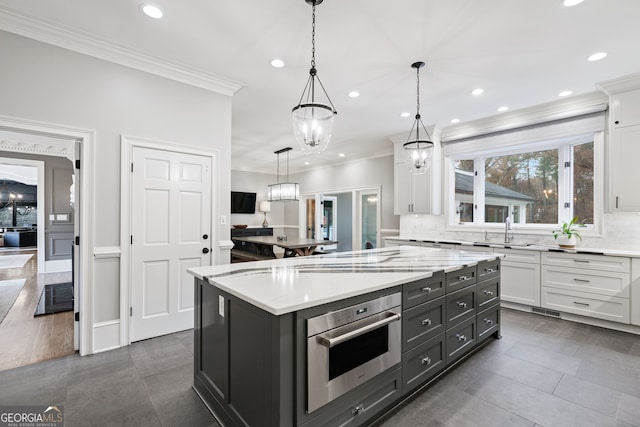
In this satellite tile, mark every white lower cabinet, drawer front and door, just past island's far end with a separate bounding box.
[494,249,540,307]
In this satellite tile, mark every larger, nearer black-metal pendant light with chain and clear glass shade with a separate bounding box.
[291,0,338,154]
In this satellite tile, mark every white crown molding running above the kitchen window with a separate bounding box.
[440,92,609,142]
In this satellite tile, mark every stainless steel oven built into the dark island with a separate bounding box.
[307,292,402,412]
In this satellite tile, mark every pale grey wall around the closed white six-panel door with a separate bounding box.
[0,32,231,351]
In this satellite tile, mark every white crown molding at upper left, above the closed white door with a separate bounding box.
[0,5,244,96]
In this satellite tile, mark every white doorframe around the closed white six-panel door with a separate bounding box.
[120,134,220,347]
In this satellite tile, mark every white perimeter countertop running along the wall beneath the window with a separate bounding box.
[385,236,640,258]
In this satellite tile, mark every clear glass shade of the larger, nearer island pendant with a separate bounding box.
[291,103,336,154]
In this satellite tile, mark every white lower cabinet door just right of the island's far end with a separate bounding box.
[500,261,540,307]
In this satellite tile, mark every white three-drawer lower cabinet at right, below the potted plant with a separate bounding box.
[541,252,631,324]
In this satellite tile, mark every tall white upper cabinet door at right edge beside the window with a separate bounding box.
[609,125,640,212]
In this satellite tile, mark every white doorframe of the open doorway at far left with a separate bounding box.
[0,115,96,356]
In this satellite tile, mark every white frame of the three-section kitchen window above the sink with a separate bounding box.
[443,131,604,237]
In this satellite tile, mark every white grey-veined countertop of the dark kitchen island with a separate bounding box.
[187,246,501,315]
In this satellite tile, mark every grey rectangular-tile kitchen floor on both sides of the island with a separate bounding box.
[0,309,640,427]
